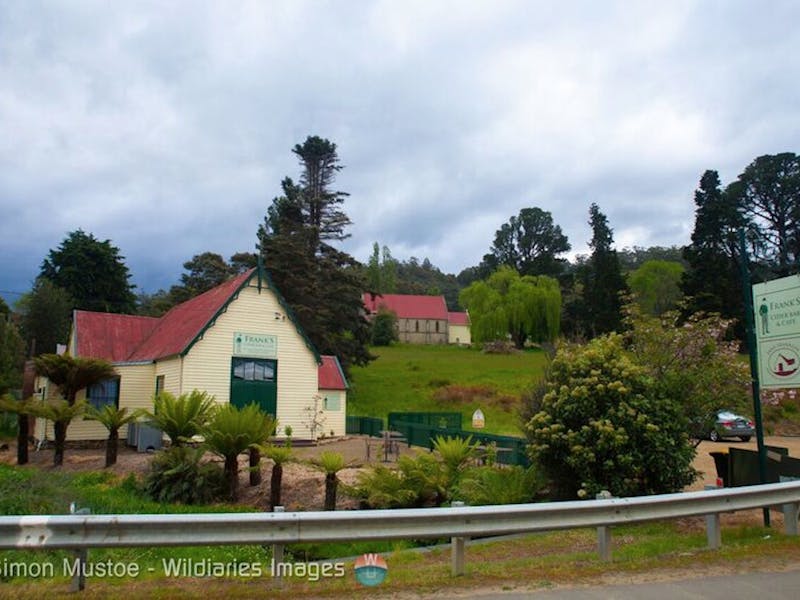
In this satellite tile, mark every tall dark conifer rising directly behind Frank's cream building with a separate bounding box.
[258,136,372,369]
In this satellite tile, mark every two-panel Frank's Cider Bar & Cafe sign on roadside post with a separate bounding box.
[753,275,800,388]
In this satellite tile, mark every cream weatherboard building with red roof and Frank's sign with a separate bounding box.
[35,269,347,440]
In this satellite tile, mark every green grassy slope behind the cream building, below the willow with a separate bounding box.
[347,344,545,435]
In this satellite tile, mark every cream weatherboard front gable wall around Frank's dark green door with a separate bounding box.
[183,282,324,438]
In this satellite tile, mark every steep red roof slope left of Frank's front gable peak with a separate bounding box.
[128,269,255,361]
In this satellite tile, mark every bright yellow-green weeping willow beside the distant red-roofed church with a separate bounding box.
[459,267,561,348]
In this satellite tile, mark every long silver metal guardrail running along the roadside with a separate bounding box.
[0,481,800,584]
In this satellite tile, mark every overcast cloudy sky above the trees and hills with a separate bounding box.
[0,0,800,301]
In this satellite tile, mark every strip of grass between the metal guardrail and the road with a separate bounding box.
[6,522,800,598]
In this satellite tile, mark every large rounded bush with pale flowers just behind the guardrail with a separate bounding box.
[528,334,695,499]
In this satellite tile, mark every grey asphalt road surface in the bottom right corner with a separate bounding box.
[460,571,800,600]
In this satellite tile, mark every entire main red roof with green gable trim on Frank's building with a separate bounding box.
[73,269,322,364]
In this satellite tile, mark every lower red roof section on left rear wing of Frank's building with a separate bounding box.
[73,310,159,362]
